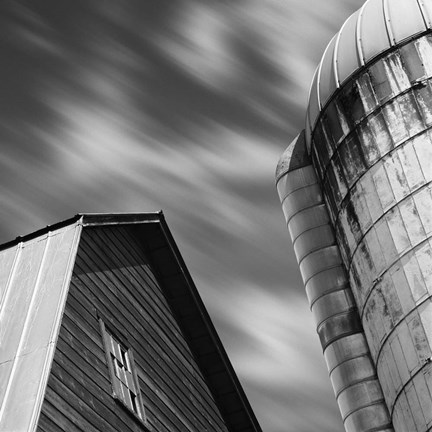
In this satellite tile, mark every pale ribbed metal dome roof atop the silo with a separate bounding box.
[306,0,432,141]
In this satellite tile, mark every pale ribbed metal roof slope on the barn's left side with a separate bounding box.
[0,223,80,431]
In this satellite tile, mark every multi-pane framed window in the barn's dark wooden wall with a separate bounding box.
[100,320,146,422]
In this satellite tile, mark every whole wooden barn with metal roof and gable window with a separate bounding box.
[0,213,260,432]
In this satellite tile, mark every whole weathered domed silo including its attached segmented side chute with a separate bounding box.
[276,0,432,432]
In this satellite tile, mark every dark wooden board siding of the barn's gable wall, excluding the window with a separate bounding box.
[38,226,227,432]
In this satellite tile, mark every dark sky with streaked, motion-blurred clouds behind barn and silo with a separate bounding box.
[0,0,363,432]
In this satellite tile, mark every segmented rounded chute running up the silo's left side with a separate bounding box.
[277,134,393,432]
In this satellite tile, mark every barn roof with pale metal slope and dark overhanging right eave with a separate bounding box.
[0,212,261,432]
